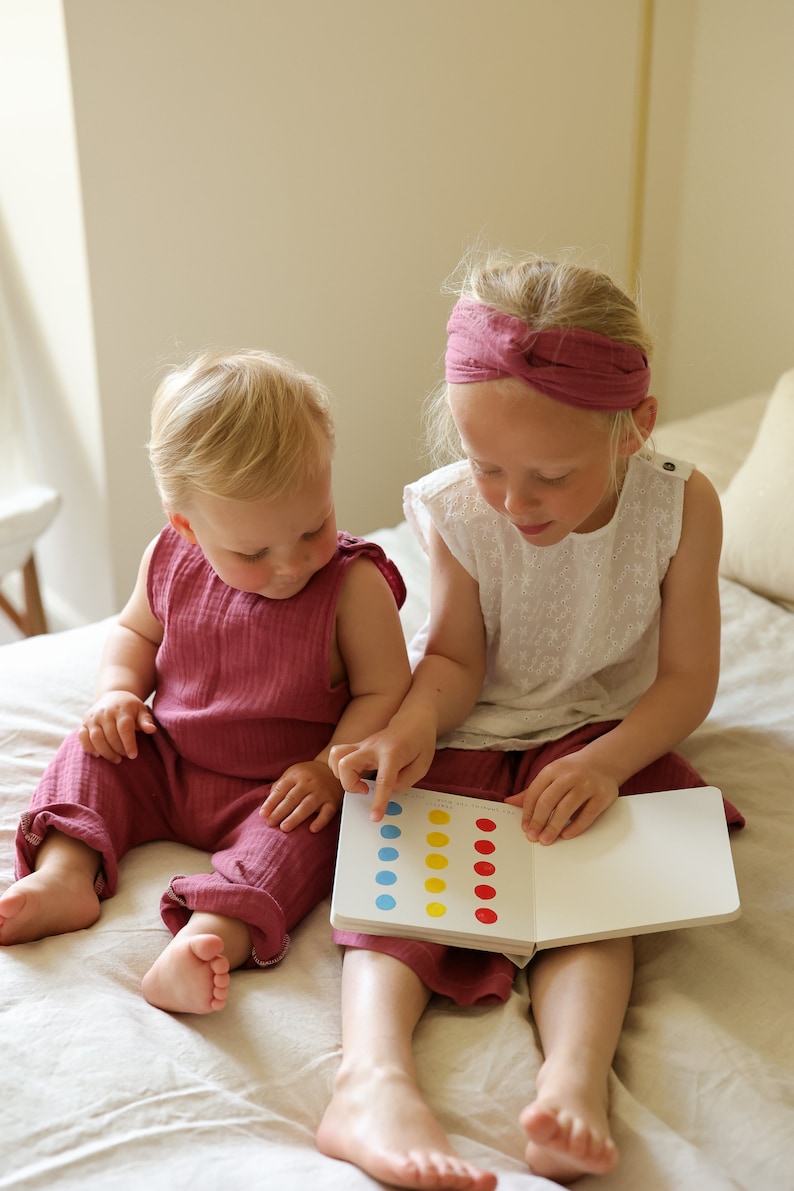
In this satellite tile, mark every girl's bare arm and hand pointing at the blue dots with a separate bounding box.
[331,528,486,819]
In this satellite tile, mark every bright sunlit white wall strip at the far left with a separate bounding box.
[0,0,115,623]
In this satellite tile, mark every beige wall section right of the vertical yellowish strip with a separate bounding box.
[658,0,794,413]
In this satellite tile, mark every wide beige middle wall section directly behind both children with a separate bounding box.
[0,0,639,615]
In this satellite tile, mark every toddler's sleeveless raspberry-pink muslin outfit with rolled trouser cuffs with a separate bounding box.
[17,526,405,967]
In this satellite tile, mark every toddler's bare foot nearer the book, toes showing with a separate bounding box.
[142,930,230,1014]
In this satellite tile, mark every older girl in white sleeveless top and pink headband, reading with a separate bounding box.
[318,257,742,1191]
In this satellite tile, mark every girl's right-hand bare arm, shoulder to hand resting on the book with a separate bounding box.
[516,472,723,843]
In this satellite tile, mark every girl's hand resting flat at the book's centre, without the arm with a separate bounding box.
[505,753,619,843]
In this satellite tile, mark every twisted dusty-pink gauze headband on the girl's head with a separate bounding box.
[446,298,651,411]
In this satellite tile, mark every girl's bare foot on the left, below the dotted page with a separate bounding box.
[317,1068,496,1191]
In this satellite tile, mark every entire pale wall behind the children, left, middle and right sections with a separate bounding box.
[0,0,792,618]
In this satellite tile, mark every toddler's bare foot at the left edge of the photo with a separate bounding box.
[0,868,99,947]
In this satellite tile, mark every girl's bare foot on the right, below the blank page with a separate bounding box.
[520,1086,618,1183]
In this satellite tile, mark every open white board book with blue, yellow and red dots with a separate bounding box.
[331,784,739,956]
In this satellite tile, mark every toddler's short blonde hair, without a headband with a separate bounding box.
[148,350,333,512]
